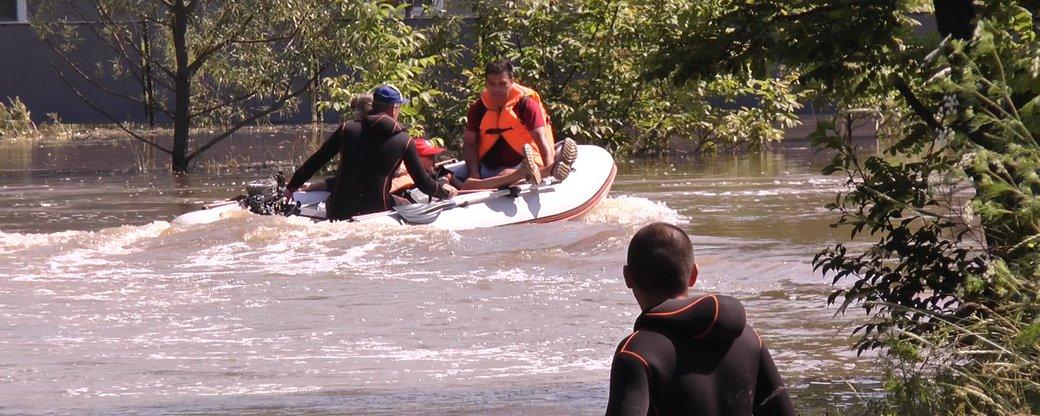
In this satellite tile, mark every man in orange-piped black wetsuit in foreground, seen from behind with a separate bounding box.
[606,223,796,416]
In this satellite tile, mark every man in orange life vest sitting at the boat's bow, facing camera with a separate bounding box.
[454,60,577,188]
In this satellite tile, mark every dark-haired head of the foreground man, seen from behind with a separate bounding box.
[628,223,694,296]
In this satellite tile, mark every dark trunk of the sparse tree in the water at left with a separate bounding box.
[172,0,191,173]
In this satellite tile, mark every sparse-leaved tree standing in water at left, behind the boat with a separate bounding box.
[33,0,407,172]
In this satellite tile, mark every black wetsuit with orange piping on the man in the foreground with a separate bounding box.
[606,294,796,416]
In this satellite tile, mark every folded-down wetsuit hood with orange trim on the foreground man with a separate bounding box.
[635,294,748,343]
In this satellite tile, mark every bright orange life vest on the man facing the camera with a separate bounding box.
[477,83,555,166]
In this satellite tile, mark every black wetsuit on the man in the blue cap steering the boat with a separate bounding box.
[287,114,447,219]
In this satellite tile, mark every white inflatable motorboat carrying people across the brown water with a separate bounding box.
[173,146,618,230]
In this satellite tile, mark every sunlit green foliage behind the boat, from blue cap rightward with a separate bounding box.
[314,0,804,153]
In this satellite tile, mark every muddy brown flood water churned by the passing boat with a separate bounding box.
[0,125,878,415]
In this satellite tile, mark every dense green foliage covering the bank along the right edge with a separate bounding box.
[654,0,1040,414]
